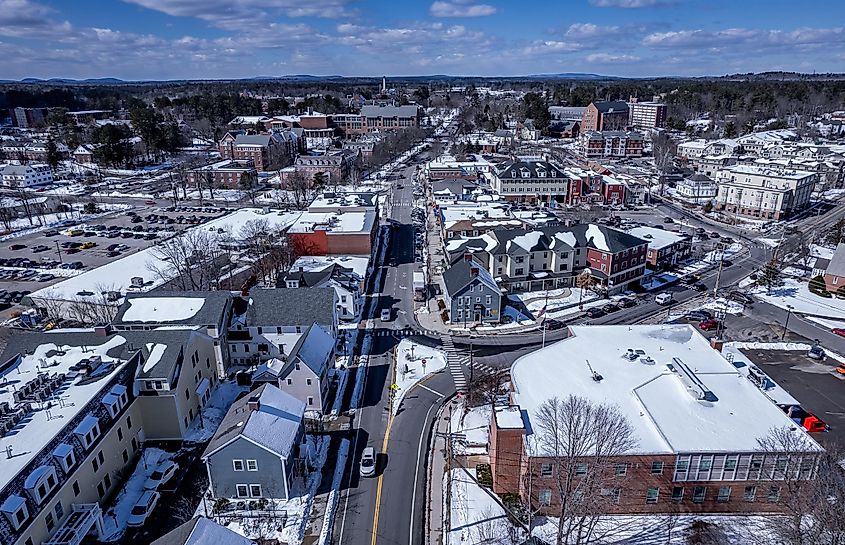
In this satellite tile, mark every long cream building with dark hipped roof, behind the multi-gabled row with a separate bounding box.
[490,159,569,204]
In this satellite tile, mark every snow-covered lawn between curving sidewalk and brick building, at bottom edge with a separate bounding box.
[443,469,516,545]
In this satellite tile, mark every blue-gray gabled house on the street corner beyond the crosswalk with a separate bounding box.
[443,254,502,324]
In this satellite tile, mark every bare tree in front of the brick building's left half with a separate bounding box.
[537,395,637,545]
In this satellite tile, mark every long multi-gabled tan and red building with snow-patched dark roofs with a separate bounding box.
[446,224,648,293]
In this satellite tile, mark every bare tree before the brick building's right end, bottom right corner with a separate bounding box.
[758,426,845,545]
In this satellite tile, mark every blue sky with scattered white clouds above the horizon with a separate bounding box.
[0,0,845,79]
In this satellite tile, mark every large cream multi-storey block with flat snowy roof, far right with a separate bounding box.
[716,165,817,221]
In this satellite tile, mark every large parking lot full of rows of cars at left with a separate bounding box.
[0,203,230,318]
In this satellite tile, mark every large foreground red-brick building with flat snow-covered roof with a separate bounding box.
[489,324,822,515]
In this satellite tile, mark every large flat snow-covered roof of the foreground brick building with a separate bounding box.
[511,324,821,454]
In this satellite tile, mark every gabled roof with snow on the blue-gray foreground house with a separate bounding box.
[202,384,305,458]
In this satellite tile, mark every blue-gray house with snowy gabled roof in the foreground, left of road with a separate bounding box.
[202,384,305,499]
